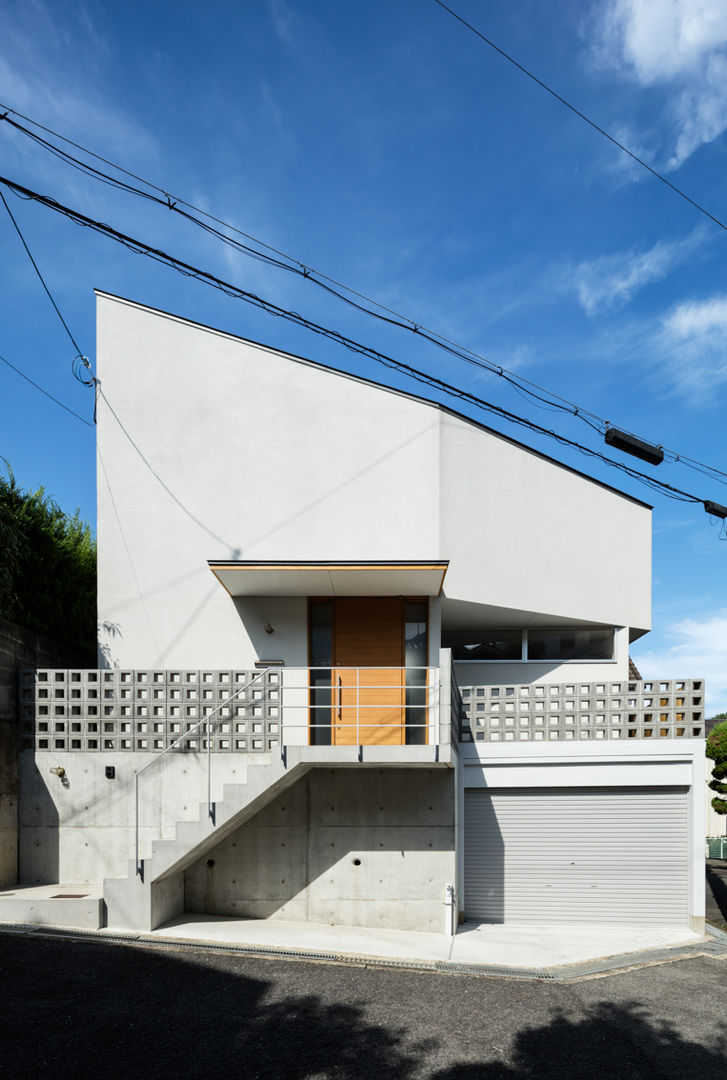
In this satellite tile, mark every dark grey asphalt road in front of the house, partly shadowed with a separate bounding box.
[0,934,727,1080]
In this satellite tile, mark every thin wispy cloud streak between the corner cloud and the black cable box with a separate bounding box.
[568,229,704,315]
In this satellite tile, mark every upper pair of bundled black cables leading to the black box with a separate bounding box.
[0,105,727,485]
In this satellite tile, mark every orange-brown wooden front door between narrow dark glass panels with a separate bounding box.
[332,596,405,746]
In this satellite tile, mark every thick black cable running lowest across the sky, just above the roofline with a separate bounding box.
[0,176,727,514]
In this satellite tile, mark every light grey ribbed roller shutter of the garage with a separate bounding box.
[465,787,689,924]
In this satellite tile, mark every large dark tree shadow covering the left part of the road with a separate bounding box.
[0,934,427,1080]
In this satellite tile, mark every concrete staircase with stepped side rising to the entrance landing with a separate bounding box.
[104,747,312,931]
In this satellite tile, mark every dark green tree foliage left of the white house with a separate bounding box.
[0,462,96,664]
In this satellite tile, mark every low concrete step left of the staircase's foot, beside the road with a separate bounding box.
[0,883,106,930]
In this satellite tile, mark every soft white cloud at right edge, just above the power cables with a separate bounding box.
[661,295,727,404]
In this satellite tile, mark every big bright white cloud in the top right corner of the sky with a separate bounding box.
[595,0,727,168]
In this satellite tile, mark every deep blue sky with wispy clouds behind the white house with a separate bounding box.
[0,0,727,710]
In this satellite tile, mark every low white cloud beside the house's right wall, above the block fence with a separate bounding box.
[634,610,727,716]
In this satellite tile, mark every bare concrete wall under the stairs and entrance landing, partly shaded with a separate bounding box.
[185,768,456,932]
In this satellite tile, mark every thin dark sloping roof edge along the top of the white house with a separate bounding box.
[94,288,654,510]
